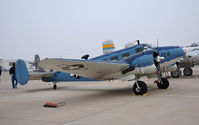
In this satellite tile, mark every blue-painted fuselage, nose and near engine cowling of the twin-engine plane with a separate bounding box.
[46,44,184,82]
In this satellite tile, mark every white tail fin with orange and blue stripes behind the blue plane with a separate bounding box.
[103,40,115,54]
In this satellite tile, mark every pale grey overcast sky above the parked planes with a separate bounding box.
[0,0,199,60]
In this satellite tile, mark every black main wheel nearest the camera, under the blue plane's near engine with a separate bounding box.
[132,81,147,95]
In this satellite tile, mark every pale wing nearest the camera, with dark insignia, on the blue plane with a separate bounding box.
[39,58,129,80]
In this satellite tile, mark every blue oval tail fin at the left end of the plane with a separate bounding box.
[15,59,30,85]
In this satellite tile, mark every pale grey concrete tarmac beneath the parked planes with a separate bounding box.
[0,67,199,125]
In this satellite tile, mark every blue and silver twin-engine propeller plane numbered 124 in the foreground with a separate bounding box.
[16,43,184,95]
